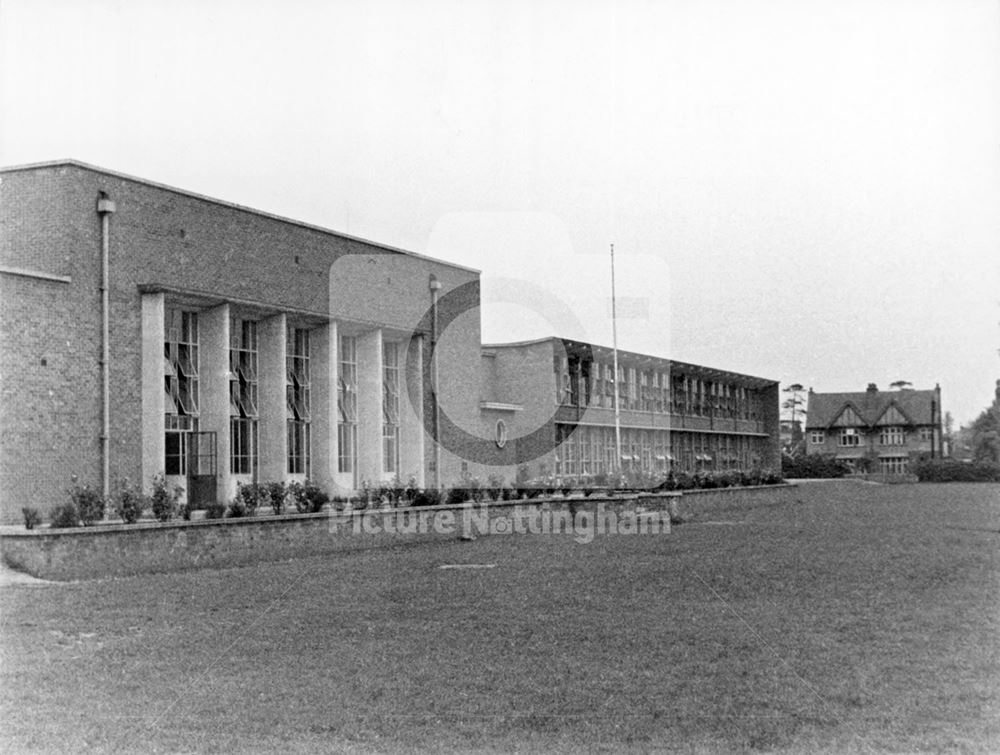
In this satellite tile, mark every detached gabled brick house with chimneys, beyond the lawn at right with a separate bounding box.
[805,383,942,474]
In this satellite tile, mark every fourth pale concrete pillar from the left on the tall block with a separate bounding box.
[309,322,339,491]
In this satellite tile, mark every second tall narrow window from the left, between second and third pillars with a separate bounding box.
[229,318,258,475]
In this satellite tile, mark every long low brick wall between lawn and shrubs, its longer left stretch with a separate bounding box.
[0,493,677,580]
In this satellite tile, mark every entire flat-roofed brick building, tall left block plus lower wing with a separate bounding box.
[0,161,778,523]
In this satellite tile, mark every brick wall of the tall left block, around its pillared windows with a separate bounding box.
[0,162,480,523]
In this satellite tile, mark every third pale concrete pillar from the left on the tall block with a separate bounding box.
[257,314,288,482]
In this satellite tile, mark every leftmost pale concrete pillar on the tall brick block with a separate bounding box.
[141,293,166,493]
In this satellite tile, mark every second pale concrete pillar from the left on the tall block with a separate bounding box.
[199,304,235,502]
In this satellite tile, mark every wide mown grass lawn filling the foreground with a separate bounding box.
[0,482,1000,752]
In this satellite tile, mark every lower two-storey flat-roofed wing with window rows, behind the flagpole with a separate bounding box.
[476,338,780,481]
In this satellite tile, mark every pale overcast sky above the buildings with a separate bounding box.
[0,0,1000,422]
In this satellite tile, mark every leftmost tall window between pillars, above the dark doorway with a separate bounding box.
[163,309,198,475]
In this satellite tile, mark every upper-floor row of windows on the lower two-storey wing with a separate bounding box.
[554,357,763,420]
